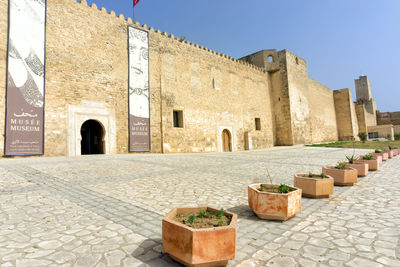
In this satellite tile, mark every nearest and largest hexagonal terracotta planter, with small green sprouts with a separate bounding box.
[162,206,237,266]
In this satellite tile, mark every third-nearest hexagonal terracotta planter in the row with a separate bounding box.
[294,172,334,198]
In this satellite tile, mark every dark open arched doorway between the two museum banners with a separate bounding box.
[81,120,104,155]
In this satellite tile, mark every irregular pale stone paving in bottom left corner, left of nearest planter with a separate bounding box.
[0,191,146,267]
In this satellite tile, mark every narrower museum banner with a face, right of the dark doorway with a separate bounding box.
[128,26,150,152]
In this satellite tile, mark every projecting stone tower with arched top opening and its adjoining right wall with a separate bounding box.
[242,50,338,145]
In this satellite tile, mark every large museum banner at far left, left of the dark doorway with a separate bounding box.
[4,0,46,155]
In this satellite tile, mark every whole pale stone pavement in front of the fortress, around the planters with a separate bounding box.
[0,147,400,267]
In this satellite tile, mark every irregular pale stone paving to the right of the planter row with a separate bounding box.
[239,151,400,267]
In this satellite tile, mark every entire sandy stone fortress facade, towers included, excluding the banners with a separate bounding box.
[0,0,382,156]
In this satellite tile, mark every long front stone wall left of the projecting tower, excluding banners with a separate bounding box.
[0,0,273,156]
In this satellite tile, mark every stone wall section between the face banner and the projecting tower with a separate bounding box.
[150,33,273,153]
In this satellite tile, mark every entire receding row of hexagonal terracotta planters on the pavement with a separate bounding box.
[162,148,400,267]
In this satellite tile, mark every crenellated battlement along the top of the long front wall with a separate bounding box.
[74,0,264,72]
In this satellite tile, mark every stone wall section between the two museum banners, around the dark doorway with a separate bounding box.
[45,0,138,156]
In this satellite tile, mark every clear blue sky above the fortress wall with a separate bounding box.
[79,0,400,111]
